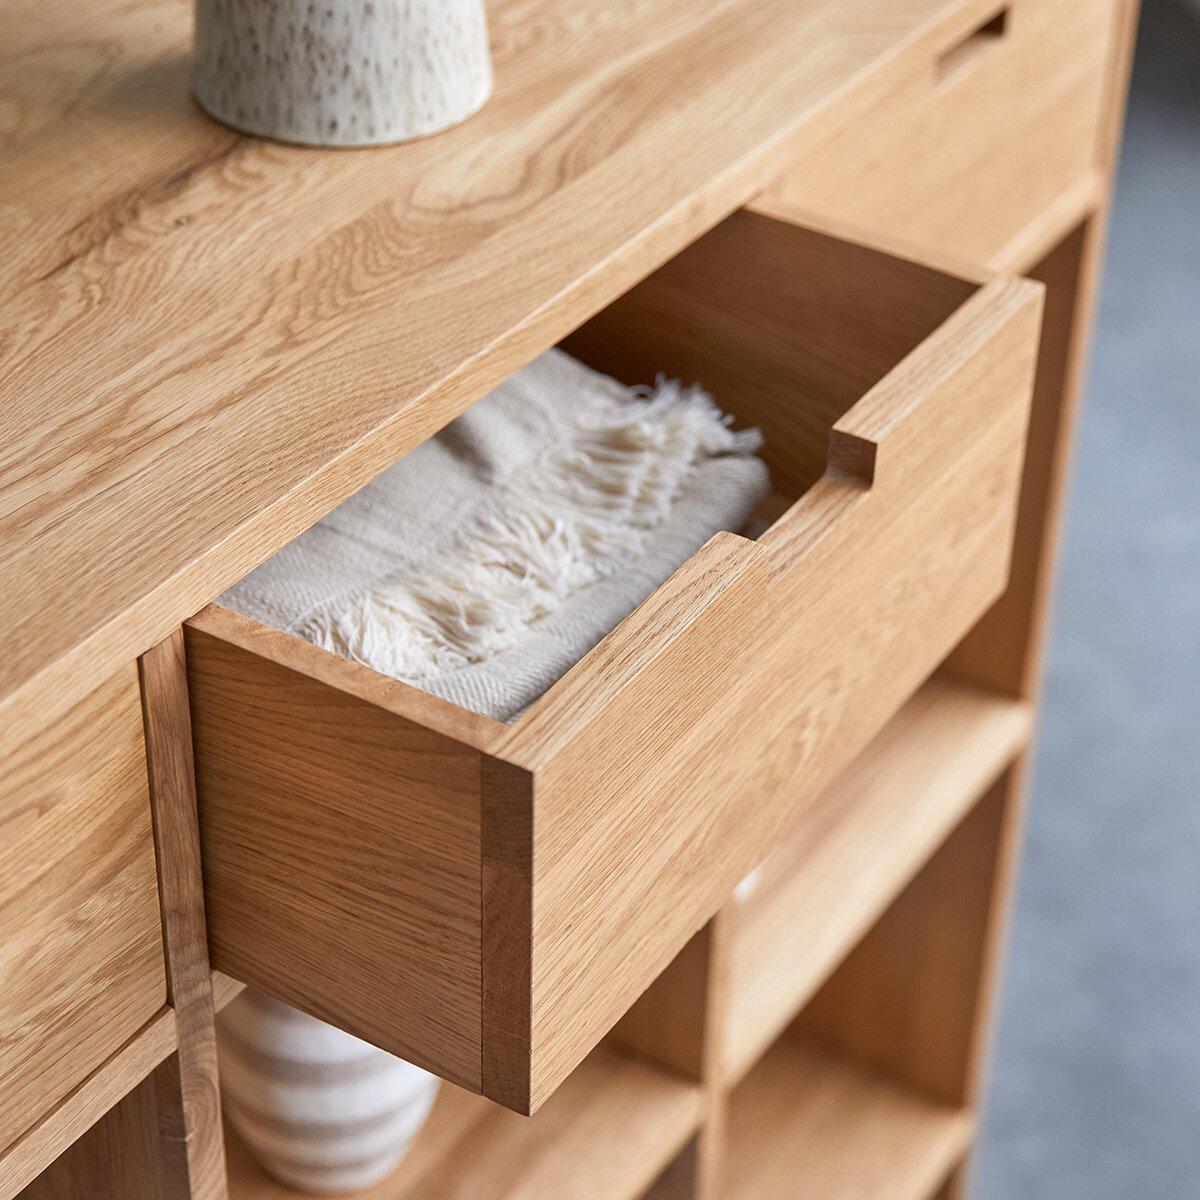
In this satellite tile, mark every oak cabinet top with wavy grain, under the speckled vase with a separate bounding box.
[0,0,969,726]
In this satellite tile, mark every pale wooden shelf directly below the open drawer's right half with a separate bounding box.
[721,677,1032,1079]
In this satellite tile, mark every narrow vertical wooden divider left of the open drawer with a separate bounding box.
[138,629,228,1200]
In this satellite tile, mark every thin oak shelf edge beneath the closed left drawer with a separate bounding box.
[0,1008,176,1200]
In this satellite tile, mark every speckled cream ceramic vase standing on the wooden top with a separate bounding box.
[192,0,492,146]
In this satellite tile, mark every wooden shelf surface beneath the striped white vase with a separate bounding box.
[227,1048,702,1200]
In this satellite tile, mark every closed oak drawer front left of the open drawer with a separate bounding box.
[0,664,167,1147]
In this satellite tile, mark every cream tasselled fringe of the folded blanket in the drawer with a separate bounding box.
[293,378,762,685]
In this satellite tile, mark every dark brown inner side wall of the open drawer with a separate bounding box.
[562,212,978,500]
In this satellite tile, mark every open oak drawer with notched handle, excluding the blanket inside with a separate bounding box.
[187,212,1040,1110]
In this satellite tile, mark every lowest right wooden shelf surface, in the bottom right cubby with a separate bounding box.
[720,1037,973,1200]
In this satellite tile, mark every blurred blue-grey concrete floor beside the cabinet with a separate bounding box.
[973,0,1200,1200]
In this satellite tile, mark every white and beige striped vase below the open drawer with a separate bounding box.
[217,989,440,1195]
